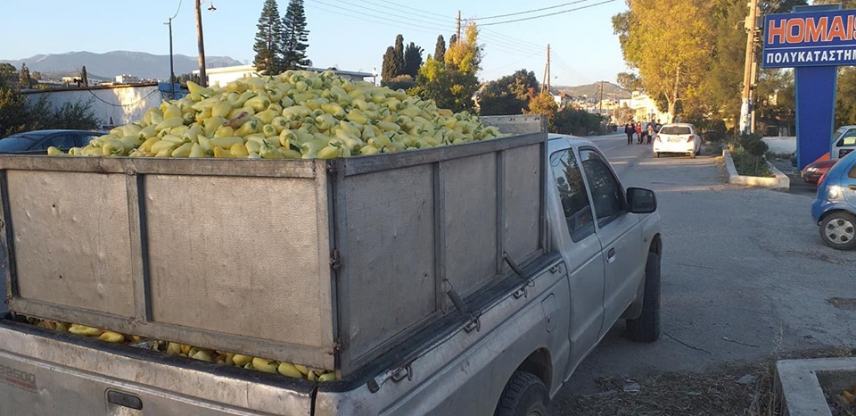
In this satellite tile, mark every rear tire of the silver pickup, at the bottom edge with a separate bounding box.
[494,371,549,416]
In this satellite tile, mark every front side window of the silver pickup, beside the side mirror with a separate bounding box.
[580,149,624,227]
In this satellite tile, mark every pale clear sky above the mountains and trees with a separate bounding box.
[0,0,627,85]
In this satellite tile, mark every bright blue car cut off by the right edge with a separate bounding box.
[811,152,856,250]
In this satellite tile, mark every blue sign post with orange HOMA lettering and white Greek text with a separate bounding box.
[761,5,856,169]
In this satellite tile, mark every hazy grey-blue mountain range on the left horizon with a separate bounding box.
[0,51,241,80]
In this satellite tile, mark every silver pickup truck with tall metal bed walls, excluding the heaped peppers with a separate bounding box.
[0,118,662,416]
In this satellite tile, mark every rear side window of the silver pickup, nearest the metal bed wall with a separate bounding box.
[550,149,594,242]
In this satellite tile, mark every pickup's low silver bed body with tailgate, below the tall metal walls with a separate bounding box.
[0,256,568,416]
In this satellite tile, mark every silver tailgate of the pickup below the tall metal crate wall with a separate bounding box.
[0,320,314,416]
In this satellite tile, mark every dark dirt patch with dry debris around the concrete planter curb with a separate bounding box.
[553,349,856,416]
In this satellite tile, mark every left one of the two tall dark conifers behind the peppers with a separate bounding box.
[253,0,285,75]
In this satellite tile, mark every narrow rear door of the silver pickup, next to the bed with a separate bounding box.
[550,149,604,370]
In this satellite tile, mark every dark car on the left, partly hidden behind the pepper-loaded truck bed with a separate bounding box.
[0,130,107,154]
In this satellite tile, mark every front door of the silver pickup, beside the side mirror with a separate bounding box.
[580,148,646,331]
